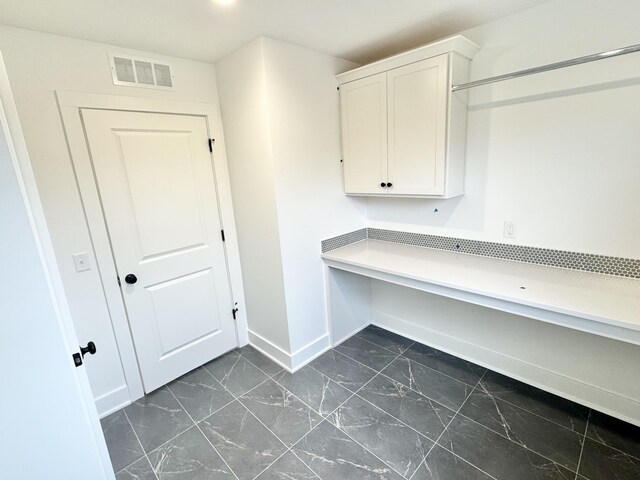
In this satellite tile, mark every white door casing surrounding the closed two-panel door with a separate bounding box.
[56,90,249,401]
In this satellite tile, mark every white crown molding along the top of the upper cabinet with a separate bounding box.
[336,35,480,85]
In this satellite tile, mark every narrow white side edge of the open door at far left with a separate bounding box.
[0,60,114,480]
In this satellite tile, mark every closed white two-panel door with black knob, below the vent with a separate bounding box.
[81,109,237,392]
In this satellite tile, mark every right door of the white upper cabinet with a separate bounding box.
[387,55,449,195]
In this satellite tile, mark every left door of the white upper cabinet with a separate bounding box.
[340,73,388,194]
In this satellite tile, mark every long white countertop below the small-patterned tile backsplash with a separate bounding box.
[322,240,640,334]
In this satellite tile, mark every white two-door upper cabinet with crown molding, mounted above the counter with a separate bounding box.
[338,36,479,198]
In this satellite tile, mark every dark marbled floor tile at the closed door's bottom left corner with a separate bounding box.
[125,387,193,453]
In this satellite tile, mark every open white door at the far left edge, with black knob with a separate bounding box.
[0,56,114,480]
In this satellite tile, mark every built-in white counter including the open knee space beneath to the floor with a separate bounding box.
[322,229,640,425]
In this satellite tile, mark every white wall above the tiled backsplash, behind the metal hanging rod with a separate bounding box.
[367,0,640,258]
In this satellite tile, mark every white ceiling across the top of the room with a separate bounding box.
[0,0,548,63]
